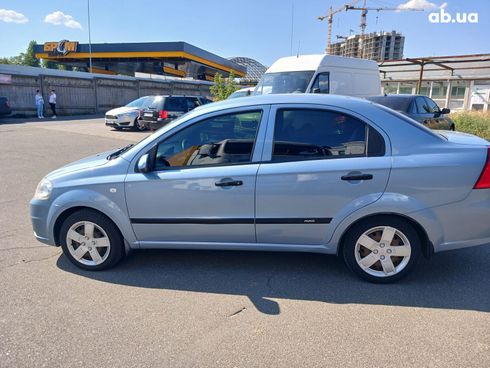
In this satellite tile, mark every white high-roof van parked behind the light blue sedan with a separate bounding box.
[254,55,381,97]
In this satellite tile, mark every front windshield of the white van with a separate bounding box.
[254,70,315,95]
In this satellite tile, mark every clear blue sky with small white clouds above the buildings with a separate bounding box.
[0,0,490,65]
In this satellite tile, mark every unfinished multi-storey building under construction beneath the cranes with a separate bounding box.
[330,31,405,61]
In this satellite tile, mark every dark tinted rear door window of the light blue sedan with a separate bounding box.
[272,109,376,161]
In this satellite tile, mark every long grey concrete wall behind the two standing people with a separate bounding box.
[0,65,212,116]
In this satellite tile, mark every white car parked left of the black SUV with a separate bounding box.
[105,96,155,130]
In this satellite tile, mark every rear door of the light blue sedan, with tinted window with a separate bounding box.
[256,105,391,245]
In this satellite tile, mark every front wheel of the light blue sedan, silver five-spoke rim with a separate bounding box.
[60,210,125,271]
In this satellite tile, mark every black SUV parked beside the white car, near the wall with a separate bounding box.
[139,95,213,130]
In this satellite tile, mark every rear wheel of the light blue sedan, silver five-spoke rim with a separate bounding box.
[342,216,421,284]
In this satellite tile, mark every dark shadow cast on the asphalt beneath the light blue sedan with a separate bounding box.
[57,247,490,315]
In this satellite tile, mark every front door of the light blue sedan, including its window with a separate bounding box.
[125,107,268,247]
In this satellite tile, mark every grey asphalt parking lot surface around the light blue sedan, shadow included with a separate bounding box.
[0,118,490,367]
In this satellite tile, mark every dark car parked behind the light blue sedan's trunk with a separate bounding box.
[367,94,456,130]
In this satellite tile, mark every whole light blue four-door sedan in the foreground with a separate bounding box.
[31,94,490,282]
